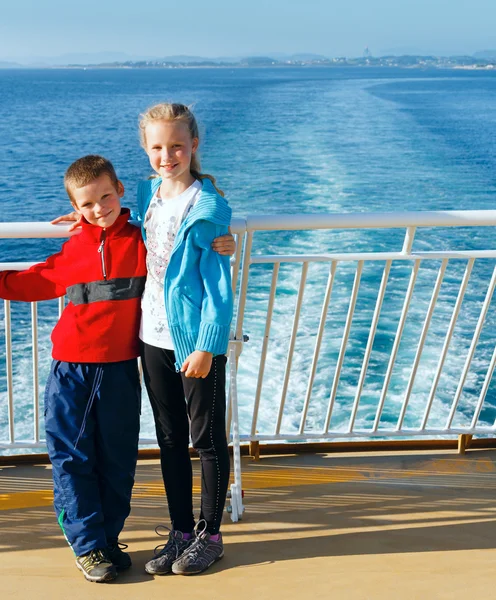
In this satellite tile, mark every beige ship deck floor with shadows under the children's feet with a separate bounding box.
[0,451,496,600]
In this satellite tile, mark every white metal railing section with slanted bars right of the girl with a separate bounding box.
[236,211,496,441]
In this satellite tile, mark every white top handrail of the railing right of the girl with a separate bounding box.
[246,210,496,231]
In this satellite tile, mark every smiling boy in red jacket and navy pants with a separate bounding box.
[0,155,146,582]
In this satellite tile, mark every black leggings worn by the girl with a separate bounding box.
[142,343,230,535]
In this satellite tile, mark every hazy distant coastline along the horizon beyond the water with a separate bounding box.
[0,51,496,70]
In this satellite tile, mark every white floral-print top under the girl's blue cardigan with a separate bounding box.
[139,181,202,350]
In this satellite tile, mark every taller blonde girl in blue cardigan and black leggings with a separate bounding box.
[138,104,232,575]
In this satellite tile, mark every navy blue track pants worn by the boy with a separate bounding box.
[45,360,141,556]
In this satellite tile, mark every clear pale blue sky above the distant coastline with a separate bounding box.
[0,0,496,60]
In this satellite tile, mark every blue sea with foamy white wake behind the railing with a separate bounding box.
[0,68,496,450]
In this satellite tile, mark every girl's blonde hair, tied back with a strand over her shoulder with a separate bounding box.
[139,102,224,196]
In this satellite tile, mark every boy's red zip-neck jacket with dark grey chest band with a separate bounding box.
[0,209,146,363]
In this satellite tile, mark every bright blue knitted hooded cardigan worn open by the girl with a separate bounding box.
[138,178,233,370]
